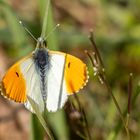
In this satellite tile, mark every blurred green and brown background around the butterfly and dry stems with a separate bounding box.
[0,0,140,140]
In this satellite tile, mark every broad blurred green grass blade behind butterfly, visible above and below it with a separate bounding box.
[38,0,69,140]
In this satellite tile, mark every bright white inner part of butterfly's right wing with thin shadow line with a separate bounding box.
[46,53,68,112]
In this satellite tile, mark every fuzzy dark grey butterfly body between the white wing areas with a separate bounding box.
[33,48,50,102]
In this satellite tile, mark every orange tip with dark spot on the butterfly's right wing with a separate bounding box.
[64,54,88,94]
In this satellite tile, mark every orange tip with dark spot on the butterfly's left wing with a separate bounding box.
[1,60,26,102]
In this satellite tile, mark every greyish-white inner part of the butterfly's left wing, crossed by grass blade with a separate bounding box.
[20,58,44,112]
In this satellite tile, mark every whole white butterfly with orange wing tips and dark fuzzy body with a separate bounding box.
[1,33,89,112]
